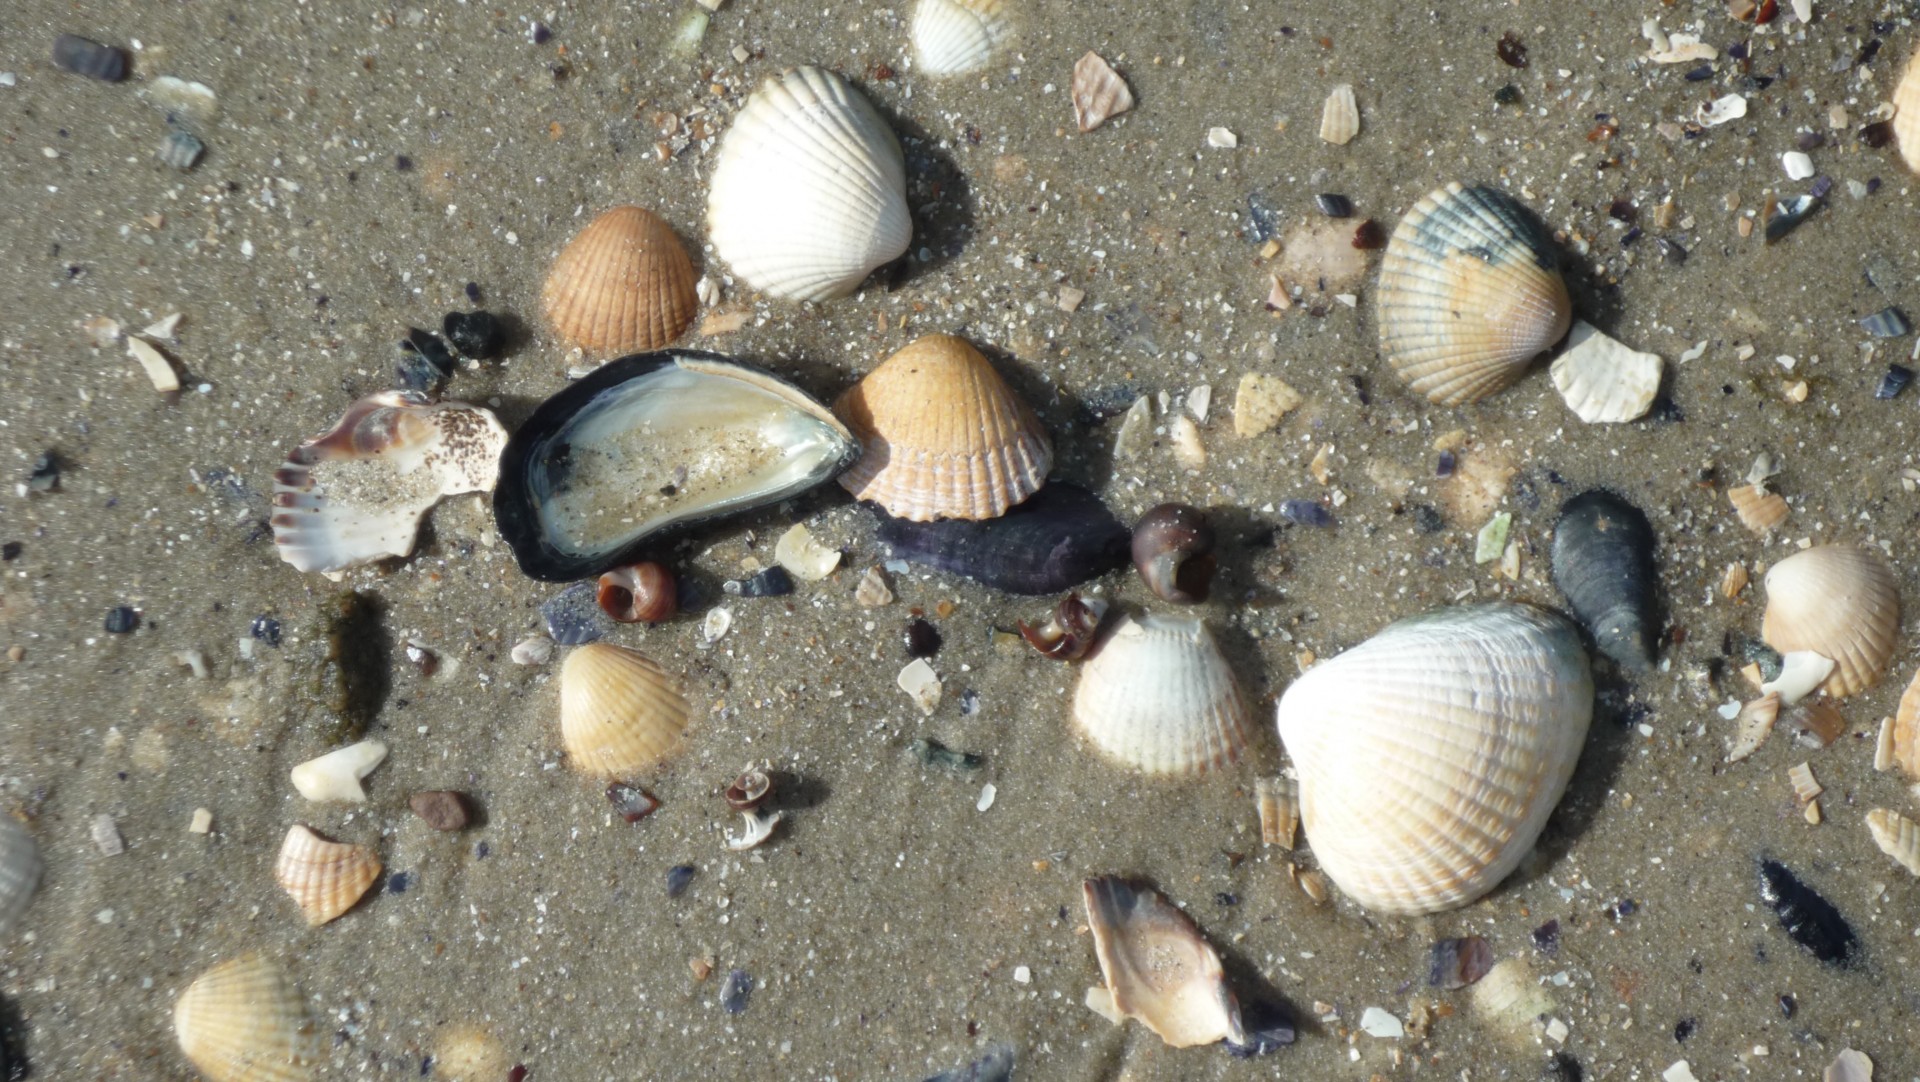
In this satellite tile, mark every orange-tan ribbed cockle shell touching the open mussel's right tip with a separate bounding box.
[833,334,1054,522]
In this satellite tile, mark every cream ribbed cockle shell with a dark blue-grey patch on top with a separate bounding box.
[1379,182,1572,405]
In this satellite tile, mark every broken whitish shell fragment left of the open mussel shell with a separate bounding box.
[273,391,507,572]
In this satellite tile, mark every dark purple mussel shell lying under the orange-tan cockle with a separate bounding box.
[872,482,1131,597]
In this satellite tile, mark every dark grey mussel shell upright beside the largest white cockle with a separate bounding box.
[1553,489,1657,671]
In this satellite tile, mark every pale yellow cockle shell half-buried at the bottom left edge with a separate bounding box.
[173,953,324,1082]
